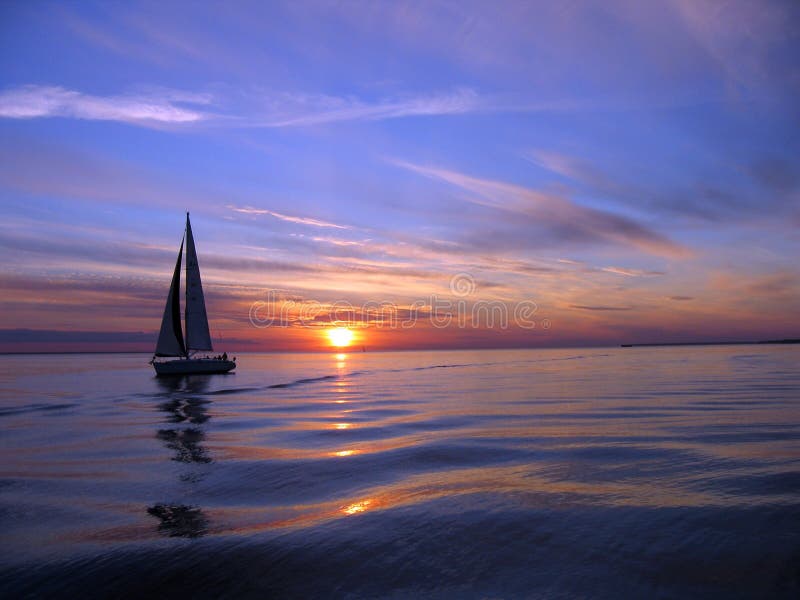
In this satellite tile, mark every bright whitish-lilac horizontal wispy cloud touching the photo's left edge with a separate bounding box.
[0,85,210,124]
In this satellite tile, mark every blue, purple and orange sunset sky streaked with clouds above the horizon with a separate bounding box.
[0,0,800,351]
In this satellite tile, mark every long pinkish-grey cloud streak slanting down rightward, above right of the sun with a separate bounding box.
[390,160,691,257]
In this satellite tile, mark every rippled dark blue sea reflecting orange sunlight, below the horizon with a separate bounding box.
[0,345,800,598]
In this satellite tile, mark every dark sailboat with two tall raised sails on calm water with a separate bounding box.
[150,212,236,375]
